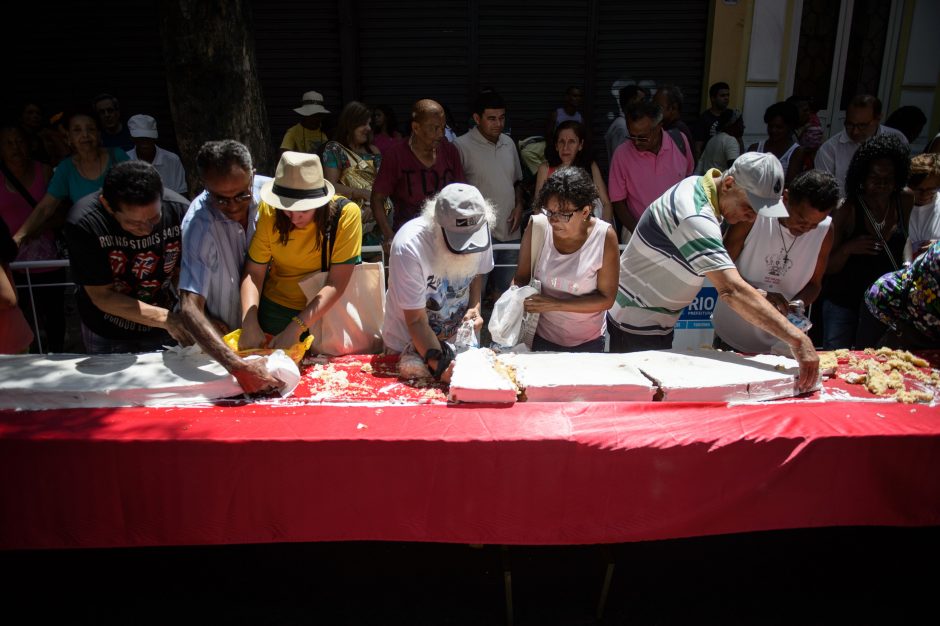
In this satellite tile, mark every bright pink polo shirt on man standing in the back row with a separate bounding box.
[607,130,695,220]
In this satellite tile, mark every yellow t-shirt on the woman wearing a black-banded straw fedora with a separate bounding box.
[248,196,362,310]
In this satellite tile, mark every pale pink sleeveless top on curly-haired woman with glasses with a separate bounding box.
[535,218,610,346]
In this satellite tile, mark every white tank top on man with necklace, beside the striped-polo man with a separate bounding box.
[712,217,832,353]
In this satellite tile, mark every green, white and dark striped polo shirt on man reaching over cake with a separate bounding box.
[610,169,734,335]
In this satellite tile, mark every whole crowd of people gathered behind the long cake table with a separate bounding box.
[0,83,940,393]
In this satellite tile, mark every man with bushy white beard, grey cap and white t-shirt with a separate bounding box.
[382,183,496,382]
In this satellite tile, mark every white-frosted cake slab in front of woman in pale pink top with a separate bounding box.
[497,352,655,402]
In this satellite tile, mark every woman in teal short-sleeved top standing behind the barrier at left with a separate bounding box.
[13,111,129,245]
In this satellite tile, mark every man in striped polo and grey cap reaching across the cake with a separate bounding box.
[608,152,819,392]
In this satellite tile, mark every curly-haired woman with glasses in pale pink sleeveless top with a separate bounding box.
[513,166,620,352]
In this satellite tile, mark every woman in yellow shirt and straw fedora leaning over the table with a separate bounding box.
[238,152,362,349]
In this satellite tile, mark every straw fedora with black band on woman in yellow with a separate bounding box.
[261,152,336,211]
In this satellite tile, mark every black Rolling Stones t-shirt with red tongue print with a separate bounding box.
[65,189,189,339]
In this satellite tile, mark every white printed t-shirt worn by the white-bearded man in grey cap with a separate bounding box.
[382,217,493,352]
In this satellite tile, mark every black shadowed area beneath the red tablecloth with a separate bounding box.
[3,528,940,625]
